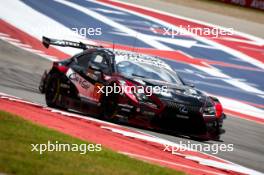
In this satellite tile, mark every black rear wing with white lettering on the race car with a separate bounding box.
[42,36,103,50]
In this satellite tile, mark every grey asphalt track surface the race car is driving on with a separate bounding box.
[0,40,264,172]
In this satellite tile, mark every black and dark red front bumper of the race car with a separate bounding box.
[112,97,225,137]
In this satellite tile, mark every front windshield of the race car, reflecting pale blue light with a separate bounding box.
[117,60,182,85]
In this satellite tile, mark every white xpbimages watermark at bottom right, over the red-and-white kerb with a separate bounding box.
[163,141,234,154]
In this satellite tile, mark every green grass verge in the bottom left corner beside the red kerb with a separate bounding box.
[0,111,183,175]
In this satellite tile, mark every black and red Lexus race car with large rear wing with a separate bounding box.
[39,37,225,140]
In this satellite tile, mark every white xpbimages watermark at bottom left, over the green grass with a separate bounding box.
[31,140,102,154]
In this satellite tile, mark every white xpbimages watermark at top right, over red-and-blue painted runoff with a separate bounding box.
[161,25,234,38]
